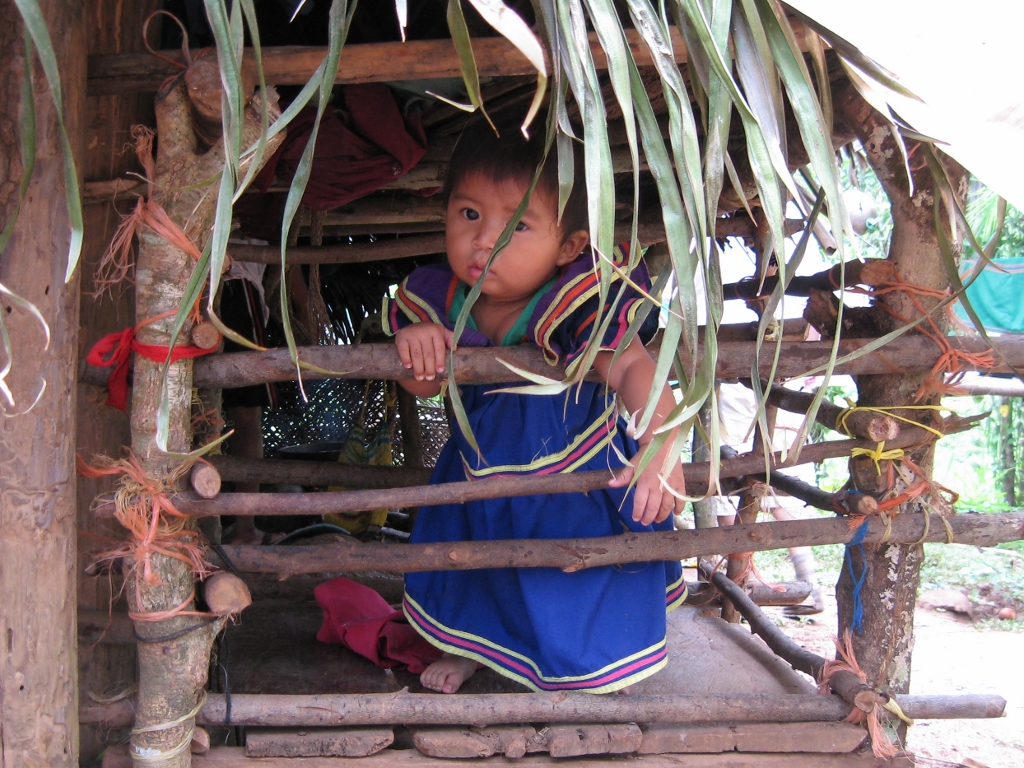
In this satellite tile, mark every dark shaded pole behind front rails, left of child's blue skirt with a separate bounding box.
[209,455,431,487]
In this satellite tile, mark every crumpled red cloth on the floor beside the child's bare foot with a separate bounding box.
[313,577,441,675]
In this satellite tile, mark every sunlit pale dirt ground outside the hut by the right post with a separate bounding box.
[766,589,1024,768]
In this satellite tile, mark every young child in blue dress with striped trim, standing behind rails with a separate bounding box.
[384,115,685,693]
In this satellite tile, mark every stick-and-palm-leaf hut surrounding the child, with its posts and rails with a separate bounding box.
[0,0,1024,768]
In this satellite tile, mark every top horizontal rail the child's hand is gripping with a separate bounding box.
[169,334,1024,389]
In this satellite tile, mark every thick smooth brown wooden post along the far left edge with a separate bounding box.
[0,0,86,768]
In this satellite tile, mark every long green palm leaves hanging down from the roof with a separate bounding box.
[4,0,925,479]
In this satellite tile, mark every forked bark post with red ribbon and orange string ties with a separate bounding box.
[92,43,283,768]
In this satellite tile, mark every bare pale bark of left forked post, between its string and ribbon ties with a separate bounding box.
[128,67,280,768]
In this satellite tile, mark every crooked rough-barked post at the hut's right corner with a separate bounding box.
[837,87,967,716]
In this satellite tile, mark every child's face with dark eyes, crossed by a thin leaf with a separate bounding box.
[444,174,588,301]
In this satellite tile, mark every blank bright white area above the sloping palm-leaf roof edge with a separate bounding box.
[786,0,1024,210]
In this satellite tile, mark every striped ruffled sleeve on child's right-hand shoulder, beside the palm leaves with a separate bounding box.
[529,246,658,365]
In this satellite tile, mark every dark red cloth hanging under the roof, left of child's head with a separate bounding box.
[260,83,427,211]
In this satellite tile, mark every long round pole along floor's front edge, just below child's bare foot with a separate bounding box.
[79,691,1006,727]
